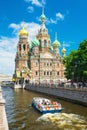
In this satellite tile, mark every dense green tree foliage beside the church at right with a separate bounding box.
[63,40,87,82]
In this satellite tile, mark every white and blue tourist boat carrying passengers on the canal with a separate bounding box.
[32,97,62,114]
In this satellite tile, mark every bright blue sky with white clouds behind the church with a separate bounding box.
[0,0,87,75]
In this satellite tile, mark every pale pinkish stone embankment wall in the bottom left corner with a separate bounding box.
[0,86,9,130]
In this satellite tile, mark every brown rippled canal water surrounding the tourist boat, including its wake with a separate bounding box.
[2,87,87,130]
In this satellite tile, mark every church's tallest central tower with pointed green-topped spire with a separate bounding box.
[37,9,50,52]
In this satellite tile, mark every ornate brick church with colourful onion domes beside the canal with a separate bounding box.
[14,11,66,84]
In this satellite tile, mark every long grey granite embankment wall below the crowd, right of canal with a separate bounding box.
[25,85,87,106]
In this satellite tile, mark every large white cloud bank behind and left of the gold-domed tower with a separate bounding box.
[0,22,40,75]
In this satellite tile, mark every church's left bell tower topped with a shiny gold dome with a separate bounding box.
[15,27,29,77]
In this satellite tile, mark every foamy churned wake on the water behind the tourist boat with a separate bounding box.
[37,113,87,130]
